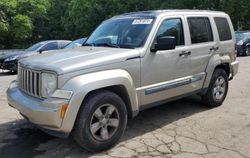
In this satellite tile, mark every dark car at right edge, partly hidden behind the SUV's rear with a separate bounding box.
[235,31,250,56]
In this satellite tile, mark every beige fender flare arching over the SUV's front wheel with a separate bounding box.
[61,69,139,133]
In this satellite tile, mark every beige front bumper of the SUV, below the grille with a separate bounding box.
[7,82,69,133]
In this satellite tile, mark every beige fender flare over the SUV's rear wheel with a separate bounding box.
[203,54,231,88]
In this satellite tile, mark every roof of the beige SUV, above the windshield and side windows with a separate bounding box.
[113,9,225,18]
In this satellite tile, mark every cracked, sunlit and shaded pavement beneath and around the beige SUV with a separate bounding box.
[0,57,250,158]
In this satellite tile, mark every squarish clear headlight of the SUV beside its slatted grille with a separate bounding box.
[41,73,57,98]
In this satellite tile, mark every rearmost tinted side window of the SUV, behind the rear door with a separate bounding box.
[214,18,232,41]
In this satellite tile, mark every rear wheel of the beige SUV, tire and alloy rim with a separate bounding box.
[202,69,228,107]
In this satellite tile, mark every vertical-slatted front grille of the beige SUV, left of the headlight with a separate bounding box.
[18,66,41,98]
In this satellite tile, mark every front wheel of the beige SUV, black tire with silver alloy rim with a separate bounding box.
[73,91,127,152]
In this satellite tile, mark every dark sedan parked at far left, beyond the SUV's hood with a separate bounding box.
[0,40,71,71]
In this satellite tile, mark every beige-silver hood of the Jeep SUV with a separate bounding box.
[20,47,140,75]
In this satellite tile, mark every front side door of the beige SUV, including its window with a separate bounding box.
[140,16,200,105]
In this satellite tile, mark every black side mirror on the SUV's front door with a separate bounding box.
[151,36,176,52]
